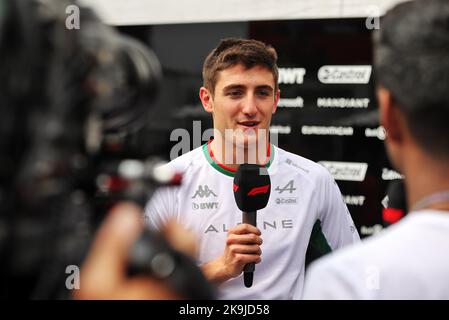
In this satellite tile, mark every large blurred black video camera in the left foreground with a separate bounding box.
[0,0,212,299]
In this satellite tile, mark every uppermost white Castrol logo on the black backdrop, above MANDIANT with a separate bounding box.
[318,65,372,84]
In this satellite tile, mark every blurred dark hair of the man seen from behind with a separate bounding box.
[374,0,449,157]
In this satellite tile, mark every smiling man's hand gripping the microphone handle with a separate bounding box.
[201,223,262,284]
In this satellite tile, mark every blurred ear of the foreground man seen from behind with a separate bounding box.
[377,86,405,143]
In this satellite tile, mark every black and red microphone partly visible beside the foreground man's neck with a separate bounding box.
[382,179,408,227]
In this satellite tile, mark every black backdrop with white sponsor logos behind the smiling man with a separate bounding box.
[119,19,401,237]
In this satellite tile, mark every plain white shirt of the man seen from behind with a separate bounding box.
[304,210,449,299]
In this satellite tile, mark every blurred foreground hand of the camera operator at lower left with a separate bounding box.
[74,202,196,299]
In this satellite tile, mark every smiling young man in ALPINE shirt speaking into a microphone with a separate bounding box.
[146,39,359,299]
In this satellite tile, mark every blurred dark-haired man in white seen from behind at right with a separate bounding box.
[305,0,449,299]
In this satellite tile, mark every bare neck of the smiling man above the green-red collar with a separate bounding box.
[210,139,269,170]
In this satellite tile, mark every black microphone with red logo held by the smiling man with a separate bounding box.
[233,163,271,288]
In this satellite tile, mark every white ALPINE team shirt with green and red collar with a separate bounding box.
[145,144,360,299]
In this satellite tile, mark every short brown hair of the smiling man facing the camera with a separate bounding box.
[203,38,278,94]
